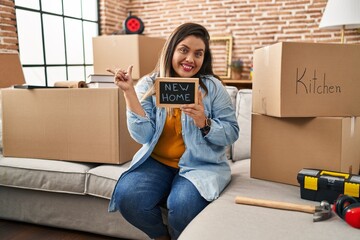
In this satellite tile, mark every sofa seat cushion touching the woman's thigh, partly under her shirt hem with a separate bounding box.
[86,162,130,199]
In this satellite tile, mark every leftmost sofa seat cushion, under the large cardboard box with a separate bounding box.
[0,156,96,194]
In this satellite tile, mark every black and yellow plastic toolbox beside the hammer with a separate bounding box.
[297,168,360,203]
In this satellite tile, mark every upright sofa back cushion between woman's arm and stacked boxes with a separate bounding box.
[232,89,252,161]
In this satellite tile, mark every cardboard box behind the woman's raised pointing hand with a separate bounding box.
[93,34,165,80]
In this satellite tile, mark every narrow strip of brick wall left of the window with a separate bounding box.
[0,0,18,52]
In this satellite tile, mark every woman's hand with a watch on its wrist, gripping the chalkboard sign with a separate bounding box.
[181,90,206,128]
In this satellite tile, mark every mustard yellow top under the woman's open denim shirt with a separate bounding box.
[151,108,185,168]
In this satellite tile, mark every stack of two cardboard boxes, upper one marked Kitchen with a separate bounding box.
[251,42,360,185]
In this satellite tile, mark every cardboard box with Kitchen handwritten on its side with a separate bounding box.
[253,42,360,117]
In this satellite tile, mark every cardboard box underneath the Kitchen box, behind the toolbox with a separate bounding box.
[250,114,360,185]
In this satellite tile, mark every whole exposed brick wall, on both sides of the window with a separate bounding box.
[0,0,360,76]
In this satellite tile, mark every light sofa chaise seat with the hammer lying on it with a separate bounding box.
[178,160,360,240]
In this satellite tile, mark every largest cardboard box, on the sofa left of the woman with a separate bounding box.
[2,88,140,164]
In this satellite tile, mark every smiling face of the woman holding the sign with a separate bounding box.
[172,35,205,77]
